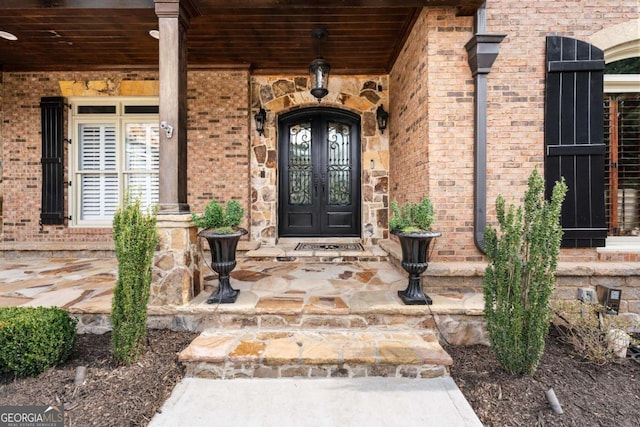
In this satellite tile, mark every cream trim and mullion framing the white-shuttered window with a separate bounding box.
[68,97,160,228]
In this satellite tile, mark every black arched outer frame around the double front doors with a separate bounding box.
[277,107,362,237]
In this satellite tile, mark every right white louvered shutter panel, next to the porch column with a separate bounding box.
[125,123,160,209]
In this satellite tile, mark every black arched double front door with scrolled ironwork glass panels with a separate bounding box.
[278,108,360,237]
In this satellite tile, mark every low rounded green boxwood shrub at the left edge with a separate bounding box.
[0,307,77,377]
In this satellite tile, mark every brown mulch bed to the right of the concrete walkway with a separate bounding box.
[446,329,640,427]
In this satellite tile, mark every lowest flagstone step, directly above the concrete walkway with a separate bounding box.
[179,328,452,379]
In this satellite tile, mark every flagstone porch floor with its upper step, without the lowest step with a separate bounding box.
[0,258,483,332]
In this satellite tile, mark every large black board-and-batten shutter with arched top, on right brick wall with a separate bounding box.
[544,36,607,248]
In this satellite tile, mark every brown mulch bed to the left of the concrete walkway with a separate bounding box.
[0,330,198,427]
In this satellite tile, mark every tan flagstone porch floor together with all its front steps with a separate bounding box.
[0,254,485,378]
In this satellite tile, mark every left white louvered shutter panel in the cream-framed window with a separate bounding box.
[78,123,118,220]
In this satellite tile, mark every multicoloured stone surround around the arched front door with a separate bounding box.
[250,75,393,244]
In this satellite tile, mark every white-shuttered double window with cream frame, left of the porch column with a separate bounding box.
[69,98,160,227]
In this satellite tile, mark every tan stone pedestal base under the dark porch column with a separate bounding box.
[149,215,202,306]
